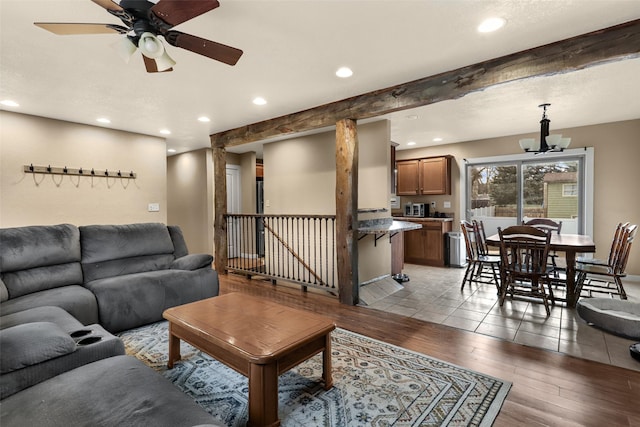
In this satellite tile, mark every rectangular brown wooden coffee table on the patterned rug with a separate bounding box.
[163,293,335,426]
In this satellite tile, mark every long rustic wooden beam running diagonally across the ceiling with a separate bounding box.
[211,19,640,147]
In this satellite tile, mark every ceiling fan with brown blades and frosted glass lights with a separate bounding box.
[34,0,242,73]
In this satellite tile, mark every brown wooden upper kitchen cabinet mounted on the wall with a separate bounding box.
[396,156,451,196]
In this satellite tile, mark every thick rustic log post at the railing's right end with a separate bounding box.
[336,119,359,305]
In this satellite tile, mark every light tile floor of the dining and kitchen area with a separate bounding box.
[369,264,640,371]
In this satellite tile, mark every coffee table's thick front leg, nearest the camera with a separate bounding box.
[247,363,280,427]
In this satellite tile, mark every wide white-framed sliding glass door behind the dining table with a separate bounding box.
[461,149,593,234]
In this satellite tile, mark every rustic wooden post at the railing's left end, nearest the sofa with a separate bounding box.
[213,144,229,274]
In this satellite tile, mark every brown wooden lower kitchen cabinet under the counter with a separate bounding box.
[404,219,452,267]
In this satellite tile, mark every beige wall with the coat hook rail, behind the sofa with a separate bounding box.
[0,111,167,227]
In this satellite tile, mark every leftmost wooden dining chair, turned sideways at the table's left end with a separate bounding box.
[460,221,500,292]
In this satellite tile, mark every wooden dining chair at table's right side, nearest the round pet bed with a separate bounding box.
[576,224,638,299]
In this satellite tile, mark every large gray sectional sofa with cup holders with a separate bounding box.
[0,223,218,427]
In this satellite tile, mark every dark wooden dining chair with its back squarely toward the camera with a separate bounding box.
[498,225,555,316]
